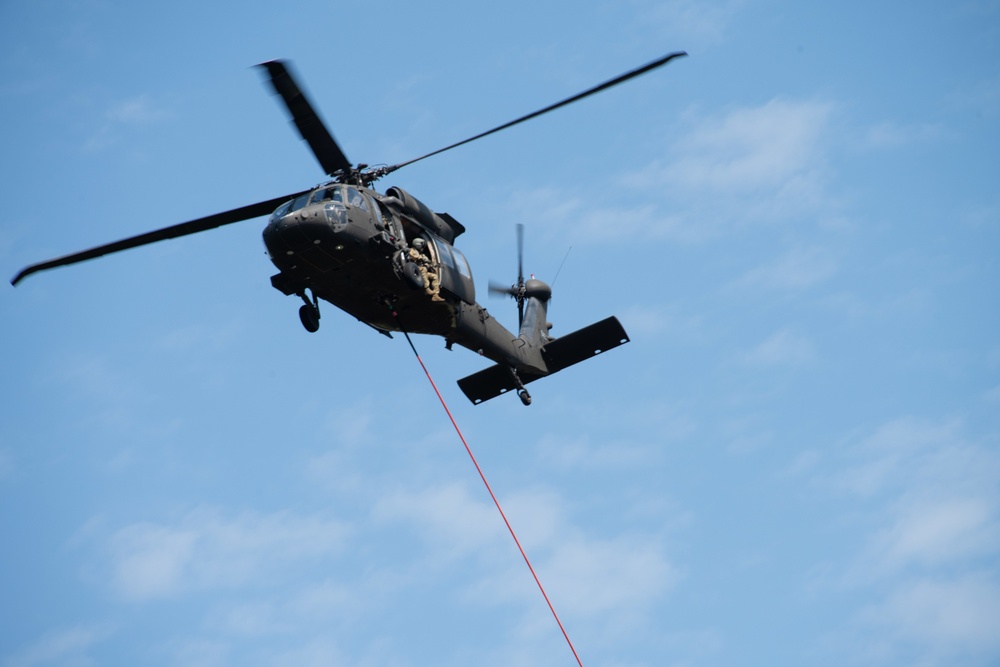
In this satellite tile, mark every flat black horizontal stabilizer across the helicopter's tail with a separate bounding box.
[458,317,629,404]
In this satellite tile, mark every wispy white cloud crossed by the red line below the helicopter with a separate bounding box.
[375,474,677,632]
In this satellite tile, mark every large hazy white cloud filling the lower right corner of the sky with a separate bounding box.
[838,418,1000,665]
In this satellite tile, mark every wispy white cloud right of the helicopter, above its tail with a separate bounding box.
[510,98,842,244]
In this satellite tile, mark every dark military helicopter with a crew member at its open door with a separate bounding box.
[11,51,687,405]
